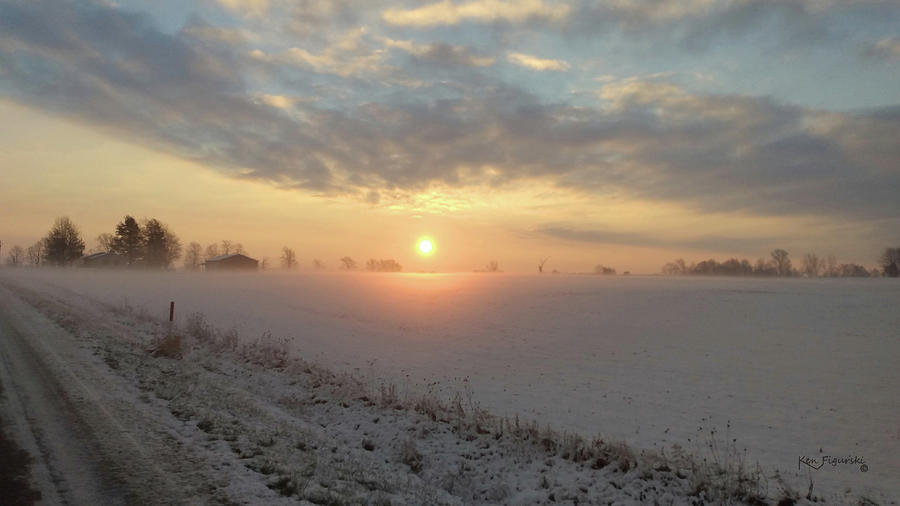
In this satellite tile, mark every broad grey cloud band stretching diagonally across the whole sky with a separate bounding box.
[0,0,900,221]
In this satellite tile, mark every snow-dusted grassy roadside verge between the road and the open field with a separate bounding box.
[4,281,857,504]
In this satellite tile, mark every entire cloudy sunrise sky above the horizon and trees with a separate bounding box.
[0,0,900,273]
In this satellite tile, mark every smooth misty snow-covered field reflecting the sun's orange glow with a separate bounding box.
[2,270,900,504]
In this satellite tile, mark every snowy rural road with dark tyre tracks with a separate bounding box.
[0,286,195,504]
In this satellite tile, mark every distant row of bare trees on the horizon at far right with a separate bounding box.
[662,248,900,278]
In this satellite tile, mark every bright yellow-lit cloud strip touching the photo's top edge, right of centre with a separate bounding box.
[382,0,571,28]
